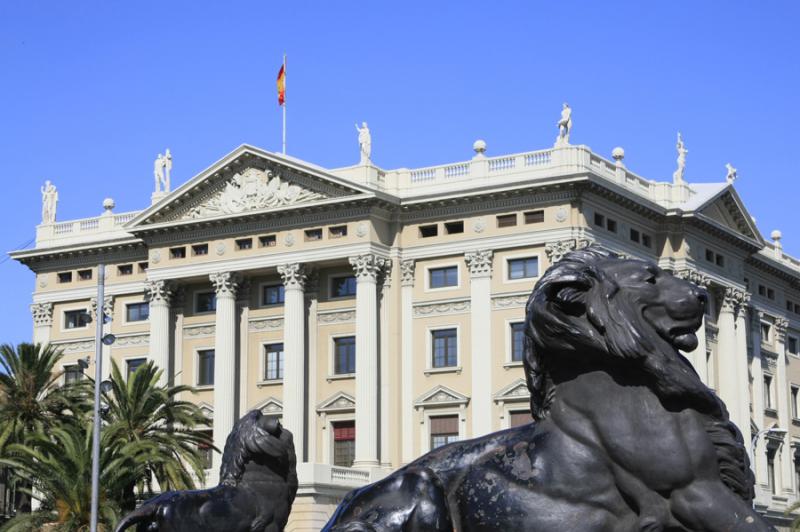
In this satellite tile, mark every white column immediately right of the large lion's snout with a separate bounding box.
[717,288,750,440]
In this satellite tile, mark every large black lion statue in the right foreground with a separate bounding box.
[324,246,771,532]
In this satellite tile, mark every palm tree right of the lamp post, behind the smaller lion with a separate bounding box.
[104,361,216,511]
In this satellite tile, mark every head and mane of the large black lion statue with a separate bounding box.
[525,246,719,419]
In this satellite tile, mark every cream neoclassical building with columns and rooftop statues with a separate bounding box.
[11,120,800,530]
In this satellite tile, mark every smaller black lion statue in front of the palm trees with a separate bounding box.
[116,410,297,532]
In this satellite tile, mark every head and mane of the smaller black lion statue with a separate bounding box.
[220,410,297,486]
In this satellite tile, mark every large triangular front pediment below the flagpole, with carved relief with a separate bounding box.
[126,145,374,232]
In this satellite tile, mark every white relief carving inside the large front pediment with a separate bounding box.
[183,167,327,220]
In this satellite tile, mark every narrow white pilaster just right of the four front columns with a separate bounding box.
[400,259,416,465]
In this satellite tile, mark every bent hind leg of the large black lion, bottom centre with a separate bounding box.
[323,466,453,532]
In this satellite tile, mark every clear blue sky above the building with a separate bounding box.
[0,0,800,342]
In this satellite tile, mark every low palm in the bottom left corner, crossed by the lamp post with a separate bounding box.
[0,417,147,532]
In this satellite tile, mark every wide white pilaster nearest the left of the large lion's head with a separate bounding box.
[464,250,492,438]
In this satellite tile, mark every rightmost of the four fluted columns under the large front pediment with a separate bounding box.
[350,253,385,468]
